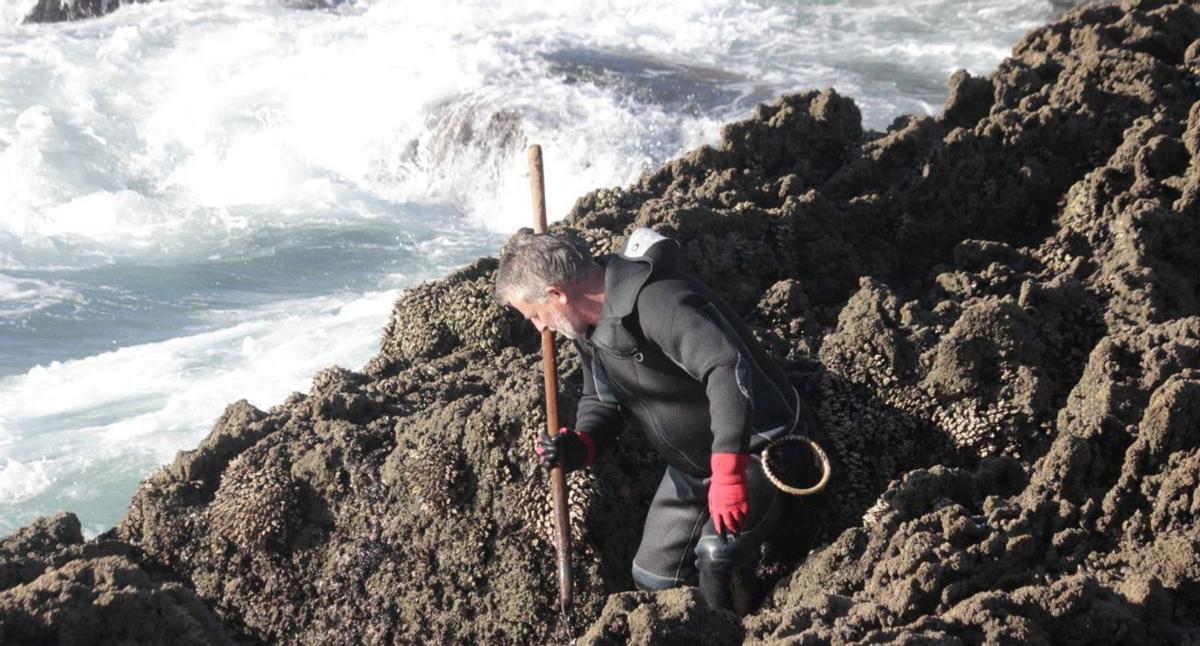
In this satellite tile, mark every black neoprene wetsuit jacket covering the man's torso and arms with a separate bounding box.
[576,229,800,477]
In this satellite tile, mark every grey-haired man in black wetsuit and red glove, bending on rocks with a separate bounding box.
[496,228,803,609]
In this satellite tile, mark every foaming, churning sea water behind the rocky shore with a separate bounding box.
[0,0,1084,536]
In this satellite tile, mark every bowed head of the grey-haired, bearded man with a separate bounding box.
[496,229,604,339]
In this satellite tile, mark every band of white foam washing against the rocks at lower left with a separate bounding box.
[0,291,396,534]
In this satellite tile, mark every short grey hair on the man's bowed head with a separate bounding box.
[493,228,599,303]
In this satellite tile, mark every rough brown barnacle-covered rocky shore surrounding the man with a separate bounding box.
[0,1,1200,644]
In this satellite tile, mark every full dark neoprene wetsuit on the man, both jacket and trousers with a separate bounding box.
[576,229,803,590]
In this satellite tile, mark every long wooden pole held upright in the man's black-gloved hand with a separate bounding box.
[529,144,571,612]
